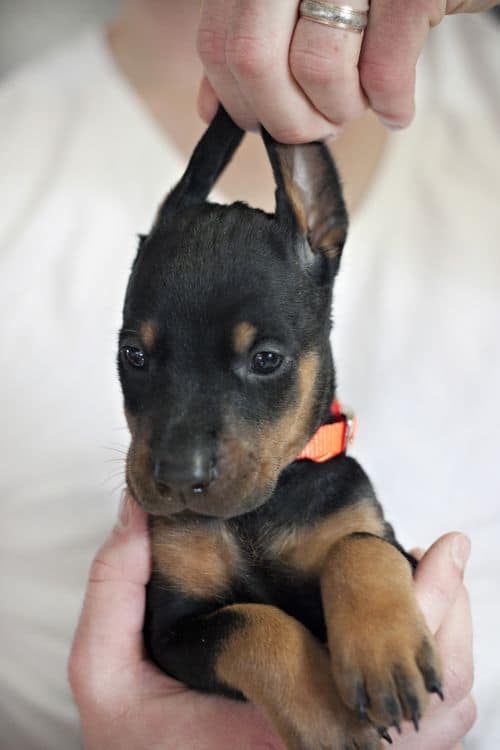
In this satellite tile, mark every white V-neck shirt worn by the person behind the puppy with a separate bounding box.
[0,17,500,750]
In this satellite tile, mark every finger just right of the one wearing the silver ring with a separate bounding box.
[360,0,444,127]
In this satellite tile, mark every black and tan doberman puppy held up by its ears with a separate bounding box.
[118,108,441,750]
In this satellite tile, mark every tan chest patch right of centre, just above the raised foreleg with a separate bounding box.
[268,500,384,575]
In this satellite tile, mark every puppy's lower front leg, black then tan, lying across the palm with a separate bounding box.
[153,604,380,750]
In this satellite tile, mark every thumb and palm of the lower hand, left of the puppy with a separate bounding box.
[69,497,284,750]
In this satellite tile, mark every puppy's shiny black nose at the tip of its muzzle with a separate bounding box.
[153,450,216,494]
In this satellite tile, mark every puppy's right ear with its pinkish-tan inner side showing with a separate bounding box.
[262,130,348,262]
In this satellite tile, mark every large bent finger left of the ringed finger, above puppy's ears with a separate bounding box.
[198,0,336,143]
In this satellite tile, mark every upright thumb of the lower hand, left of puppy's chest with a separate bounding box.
[69,493,151,680]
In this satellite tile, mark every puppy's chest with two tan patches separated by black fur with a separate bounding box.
[151,503,380,600]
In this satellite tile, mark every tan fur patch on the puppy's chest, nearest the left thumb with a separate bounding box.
[151,518,243,599]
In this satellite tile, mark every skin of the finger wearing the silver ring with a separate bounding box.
[290,0,368,125]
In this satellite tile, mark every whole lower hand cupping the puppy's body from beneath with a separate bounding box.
[69,497,474,750]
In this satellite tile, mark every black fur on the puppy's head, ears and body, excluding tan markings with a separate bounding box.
[119,109,414,724]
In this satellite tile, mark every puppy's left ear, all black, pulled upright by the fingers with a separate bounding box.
[156,106,244,225]
